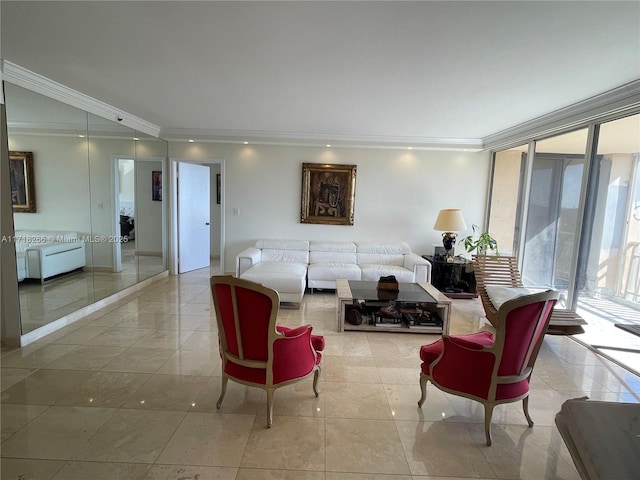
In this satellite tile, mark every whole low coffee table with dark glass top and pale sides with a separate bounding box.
[336,279,451,334]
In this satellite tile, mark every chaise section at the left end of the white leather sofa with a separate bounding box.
[236,239,309,303]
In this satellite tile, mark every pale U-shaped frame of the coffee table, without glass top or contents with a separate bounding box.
[336,279,451,335]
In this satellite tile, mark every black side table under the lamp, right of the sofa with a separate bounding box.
[422,255,478,298]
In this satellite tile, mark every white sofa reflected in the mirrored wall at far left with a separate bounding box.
[15,230,87,282]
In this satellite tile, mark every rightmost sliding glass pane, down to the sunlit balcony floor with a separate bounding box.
[576,115,640,372]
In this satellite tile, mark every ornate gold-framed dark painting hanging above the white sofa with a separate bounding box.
[300,163,356,225]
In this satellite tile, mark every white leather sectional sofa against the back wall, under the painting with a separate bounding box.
[236,239,431,303]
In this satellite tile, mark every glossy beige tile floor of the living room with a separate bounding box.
[1,269,640,480]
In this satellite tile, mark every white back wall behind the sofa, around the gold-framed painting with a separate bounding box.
[169,142,489,272]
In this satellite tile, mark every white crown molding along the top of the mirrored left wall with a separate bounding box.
[2,59,160,137]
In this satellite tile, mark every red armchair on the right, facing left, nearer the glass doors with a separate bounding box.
[418,290,558,445]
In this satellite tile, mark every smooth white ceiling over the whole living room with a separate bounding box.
[0,0,640,144]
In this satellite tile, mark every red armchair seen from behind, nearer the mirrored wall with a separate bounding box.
[211,275,324,427]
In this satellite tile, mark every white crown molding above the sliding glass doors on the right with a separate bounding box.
[483,79,640,150]
